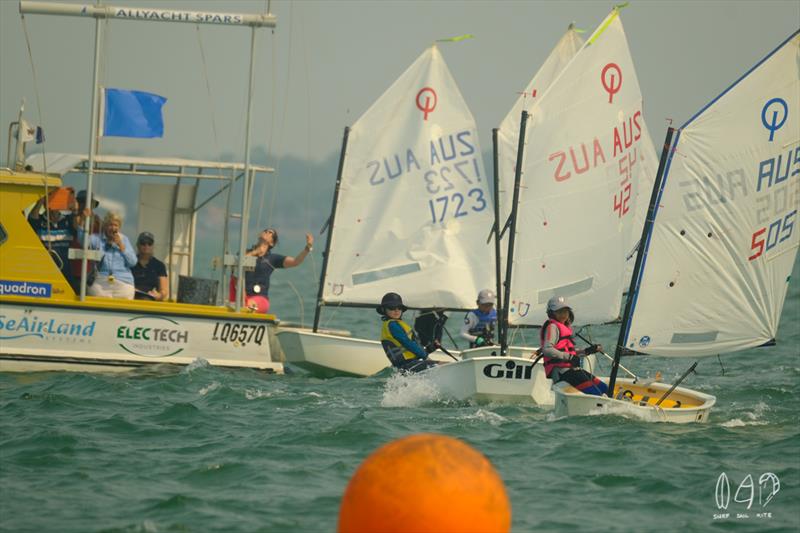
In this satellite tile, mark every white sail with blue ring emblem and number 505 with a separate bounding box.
[625,33,800,356]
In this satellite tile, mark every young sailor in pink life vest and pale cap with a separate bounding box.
[539,296,608,396]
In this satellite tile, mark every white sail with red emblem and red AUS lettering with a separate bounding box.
[509,9,652,324]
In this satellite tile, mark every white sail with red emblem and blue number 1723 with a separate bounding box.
[323,46,494,309]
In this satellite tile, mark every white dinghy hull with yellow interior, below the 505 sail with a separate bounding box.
[553,378,717,424]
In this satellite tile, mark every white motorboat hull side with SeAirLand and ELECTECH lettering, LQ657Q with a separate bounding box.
[0,302,283,374]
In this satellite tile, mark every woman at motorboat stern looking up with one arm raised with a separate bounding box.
[230,228,314,313]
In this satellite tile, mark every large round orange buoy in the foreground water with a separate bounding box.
[338,433,511,533]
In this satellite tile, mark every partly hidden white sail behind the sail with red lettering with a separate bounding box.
[497,24,583,229]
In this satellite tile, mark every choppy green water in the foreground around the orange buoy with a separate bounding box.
[0,270,800,532]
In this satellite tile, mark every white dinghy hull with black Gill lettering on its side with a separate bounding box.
[425,356,554,406]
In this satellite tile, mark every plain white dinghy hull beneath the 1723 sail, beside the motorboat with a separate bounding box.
[277,329,456,377]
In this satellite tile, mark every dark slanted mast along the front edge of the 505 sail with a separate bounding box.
[608,127,677,397]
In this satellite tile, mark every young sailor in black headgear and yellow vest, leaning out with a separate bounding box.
[375,292,439,372]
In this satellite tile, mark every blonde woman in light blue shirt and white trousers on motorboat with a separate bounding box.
[88,211,137,300]
